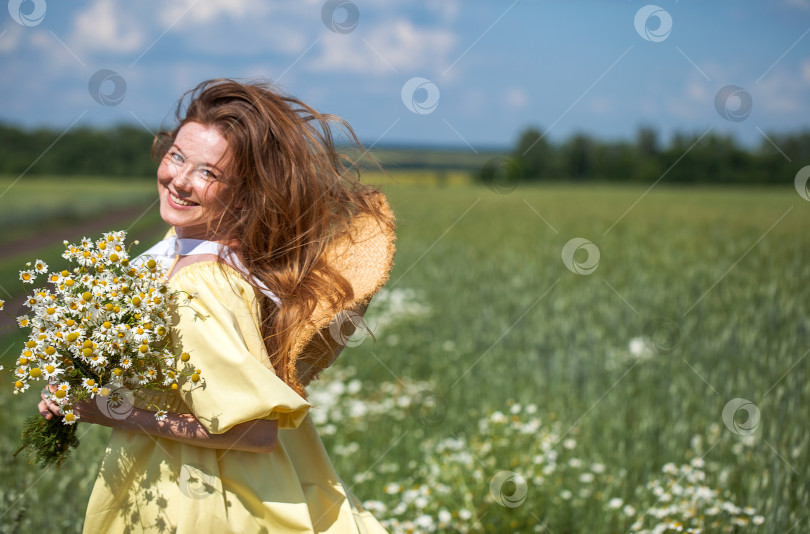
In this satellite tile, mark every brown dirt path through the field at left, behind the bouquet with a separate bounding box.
[0,204,166,338]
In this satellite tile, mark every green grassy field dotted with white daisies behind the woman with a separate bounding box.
[0,180,810,534]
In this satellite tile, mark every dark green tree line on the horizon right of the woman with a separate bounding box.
[486,126,810,186]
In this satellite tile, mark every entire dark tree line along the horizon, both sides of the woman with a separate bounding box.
[0,123,810,184]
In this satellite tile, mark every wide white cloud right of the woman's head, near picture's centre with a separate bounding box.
[309,19,456,74]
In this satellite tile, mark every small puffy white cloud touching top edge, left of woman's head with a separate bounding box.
[70,0,146,53]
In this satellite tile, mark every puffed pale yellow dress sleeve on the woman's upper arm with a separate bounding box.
[170,261,310,434]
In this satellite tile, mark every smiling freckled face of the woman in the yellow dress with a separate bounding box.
[157,122,230,240]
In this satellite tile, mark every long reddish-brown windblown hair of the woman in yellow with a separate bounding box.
[152,79,394,396]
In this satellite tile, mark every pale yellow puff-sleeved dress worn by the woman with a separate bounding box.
[84,261,385,534]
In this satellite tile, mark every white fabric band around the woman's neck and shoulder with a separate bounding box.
[131,236,281,306]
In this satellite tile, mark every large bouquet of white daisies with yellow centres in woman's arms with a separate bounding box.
[4,231,200,468]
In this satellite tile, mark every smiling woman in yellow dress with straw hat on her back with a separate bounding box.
[39,79,394,533]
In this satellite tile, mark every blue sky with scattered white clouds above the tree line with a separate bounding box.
[0,0,810,151]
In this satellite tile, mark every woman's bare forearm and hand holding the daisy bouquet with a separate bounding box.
[38,386,278,453]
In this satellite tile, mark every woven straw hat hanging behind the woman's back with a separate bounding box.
[289,194,396,391]
